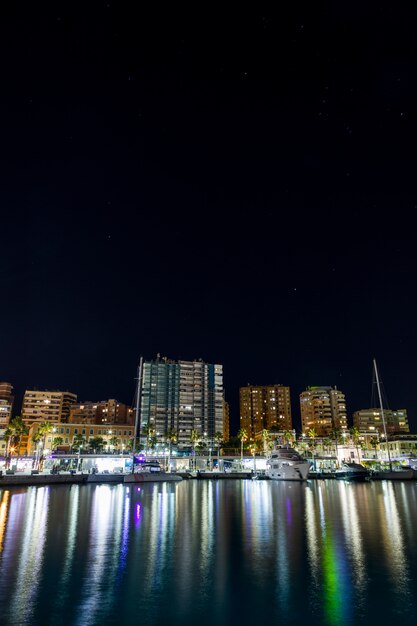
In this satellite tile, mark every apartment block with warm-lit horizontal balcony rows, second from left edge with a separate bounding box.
[22,389,77,423]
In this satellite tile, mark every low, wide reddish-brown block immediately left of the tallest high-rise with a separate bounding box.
[68,399,134,424]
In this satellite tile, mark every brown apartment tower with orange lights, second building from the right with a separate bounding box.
[300,387,347,437]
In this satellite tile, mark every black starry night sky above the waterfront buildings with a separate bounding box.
[0,0,417,431]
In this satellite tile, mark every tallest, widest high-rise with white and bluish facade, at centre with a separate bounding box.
[139,355,223,448]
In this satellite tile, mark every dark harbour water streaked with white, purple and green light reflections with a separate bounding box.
[0,480,417,626]
